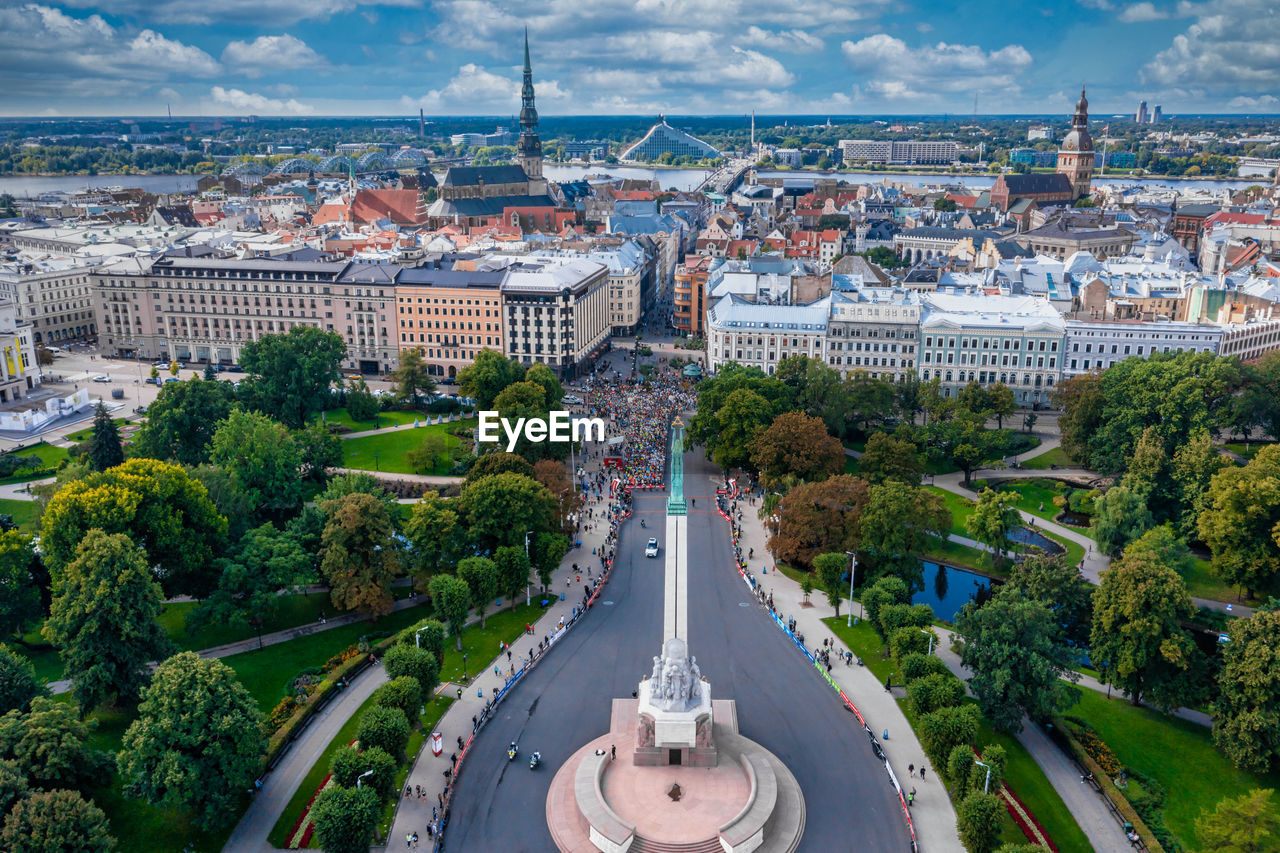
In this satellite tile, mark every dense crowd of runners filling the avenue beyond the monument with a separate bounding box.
[588,371,696,487]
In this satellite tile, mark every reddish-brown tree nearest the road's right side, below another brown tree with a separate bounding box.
[769,474,870,565]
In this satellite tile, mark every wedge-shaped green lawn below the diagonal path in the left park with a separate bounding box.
[223,597,428,713]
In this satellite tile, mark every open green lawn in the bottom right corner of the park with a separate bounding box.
[1068,690,1280,850]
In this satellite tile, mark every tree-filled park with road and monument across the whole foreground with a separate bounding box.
[0,330,1280,850]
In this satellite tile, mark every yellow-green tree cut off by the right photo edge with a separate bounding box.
[1199,444,1280,596]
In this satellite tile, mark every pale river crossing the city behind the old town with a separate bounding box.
[0,163,1258,199]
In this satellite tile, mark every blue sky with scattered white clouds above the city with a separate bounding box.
[0,0,1280,117]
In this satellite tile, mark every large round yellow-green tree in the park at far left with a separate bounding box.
[40,459,227,598]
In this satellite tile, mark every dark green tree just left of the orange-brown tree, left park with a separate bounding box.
[186,523,314,648]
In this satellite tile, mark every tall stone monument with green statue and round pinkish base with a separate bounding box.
[547,419,805,853]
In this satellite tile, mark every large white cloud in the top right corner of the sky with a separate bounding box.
[1140,0,1280,89]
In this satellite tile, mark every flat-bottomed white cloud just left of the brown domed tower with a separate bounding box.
[840,33,1032,100]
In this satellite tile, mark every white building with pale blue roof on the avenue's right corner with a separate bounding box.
[707,293,831,374]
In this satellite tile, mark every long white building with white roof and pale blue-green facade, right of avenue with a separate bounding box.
[918,289,1066,406]
